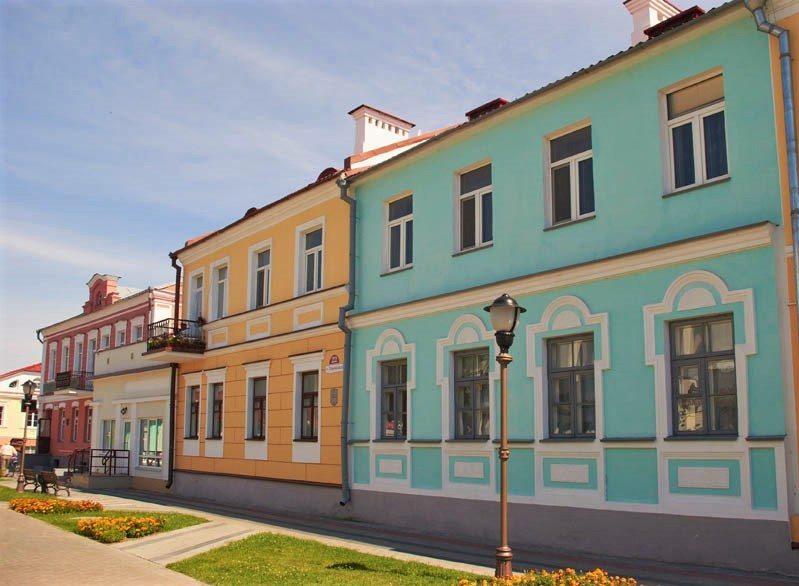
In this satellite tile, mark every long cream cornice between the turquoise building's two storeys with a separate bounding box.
[347,223,774,328]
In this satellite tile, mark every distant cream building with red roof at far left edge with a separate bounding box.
[0,363,42,451]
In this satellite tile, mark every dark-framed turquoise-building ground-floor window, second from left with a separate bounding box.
[454,348,491,439]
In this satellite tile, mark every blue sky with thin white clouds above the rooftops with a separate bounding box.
[0,0,723,372]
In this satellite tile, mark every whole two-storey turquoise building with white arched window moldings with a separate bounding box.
[348,2,799,572]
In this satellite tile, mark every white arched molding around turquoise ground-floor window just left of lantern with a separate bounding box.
[436,313,499,439]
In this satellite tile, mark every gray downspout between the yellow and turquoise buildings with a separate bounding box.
[336,171,355,507]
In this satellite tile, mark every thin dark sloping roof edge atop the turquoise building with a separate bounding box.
[350,0,744,185]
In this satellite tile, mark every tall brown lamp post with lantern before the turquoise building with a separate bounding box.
[483,293,527,579]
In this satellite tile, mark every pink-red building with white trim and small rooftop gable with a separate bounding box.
[37,274,175,467]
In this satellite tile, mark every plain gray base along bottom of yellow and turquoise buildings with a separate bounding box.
[171,471,799,583]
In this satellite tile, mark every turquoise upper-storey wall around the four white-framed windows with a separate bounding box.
[354,14,780,313]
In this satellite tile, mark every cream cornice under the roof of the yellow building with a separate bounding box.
[178,181,346,266]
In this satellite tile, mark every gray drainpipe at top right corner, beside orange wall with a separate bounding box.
[744,0,799,306]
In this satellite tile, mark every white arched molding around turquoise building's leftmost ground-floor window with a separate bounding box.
[366,328,416,439]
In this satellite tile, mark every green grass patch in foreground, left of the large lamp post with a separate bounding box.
[167,533,485,586]
